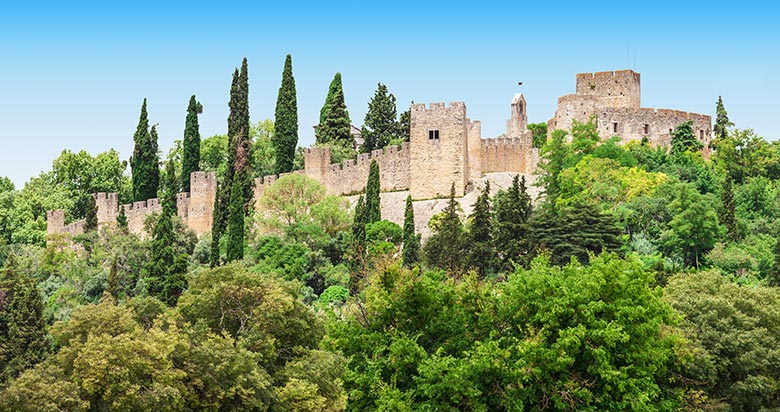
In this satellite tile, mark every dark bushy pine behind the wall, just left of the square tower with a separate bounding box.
[361,83,400,153]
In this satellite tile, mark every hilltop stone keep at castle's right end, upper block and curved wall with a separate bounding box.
[547,70,712,152]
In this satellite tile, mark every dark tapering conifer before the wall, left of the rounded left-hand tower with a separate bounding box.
[145,161,186,306]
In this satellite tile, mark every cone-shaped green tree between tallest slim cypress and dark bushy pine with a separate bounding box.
[317,73,352,147]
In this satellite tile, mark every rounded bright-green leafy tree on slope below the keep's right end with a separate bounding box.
[661,183,721,268]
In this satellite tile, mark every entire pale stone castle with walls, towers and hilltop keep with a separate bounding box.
[47,70,712,235]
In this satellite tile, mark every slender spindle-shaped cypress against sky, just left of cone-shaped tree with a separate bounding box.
[271,54,298,173]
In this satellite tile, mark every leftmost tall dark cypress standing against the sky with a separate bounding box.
[130,99,160,202]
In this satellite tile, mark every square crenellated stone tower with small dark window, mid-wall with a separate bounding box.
[409,102,469,199]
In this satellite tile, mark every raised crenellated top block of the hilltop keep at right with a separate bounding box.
[577,70,641,108]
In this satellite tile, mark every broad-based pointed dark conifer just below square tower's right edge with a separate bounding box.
[423,183,465,275]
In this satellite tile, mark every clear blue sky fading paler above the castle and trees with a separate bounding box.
[0,0,780,187]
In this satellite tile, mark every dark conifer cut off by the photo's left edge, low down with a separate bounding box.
[0,255,49,384]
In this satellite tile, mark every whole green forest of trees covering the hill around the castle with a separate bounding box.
[0,56,780,412]
